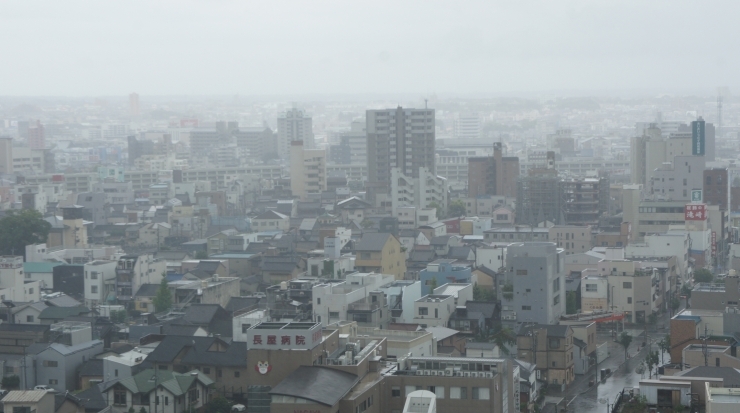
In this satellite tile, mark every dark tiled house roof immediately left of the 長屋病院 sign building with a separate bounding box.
[146,335,247,367]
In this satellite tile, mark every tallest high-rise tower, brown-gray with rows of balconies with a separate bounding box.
[366,106,436,207]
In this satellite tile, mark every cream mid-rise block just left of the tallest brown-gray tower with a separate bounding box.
[290,141,326,200]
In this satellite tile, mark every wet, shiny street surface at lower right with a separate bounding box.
[547,329,669,413]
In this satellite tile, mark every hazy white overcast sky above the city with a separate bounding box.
[0,0,740,96]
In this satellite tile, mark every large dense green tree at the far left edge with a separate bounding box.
[0,209,52,258]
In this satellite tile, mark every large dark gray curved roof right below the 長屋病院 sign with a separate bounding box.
[270,366,360,407]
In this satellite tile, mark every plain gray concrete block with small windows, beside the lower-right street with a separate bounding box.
[499,242,565,324]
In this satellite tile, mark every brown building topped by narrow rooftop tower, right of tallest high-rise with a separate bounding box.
[468,142,519,198]
